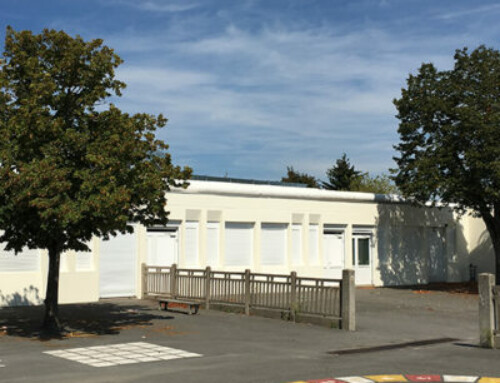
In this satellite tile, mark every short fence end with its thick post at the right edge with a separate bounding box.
[479,273,500,348]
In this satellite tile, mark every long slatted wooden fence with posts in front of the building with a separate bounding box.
[142,264,355,331]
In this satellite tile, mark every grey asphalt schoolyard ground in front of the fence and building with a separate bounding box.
[0,289,500,383]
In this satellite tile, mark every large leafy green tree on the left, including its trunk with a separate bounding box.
[0,27,191,331]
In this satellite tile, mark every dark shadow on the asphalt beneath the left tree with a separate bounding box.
[0,302,174,340]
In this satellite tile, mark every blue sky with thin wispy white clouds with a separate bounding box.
[0,0,500,180]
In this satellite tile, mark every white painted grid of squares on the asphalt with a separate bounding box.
[43,342,202,368]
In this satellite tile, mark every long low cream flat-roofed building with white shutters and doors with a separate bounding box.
[0,180,494,305]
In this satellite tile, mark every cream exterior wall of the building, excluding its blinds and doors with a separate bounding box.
[0,181,494,306]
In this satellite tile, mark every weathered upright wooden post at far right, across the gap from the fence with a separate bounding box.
[479,273,495,348]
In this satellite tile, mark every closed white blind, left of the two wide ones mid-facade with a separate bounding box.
[225,222,254,266]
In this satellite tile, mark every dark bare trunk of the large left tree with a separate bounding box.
[42,246,61,334]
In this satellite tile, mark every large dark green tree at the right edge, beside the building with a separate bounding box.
[394,46,500,284]
